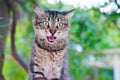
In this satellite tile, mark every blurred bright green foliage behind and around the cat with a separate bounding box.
[3,0,120,80]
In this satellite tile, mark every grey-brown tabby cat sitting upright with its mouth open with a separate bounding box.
[30,6,74,80]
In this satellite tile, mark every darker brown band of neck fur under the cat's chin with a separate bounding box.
[34,36,68,52]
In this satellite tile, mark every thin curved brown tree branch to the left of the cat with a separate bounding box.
[7,0,28,72]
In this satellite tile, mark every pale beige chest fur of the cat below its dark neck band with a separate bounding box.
[31,46,66,79]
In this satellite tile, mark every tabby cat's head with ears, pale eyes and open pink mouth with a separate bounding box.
[33,6,74,43]
